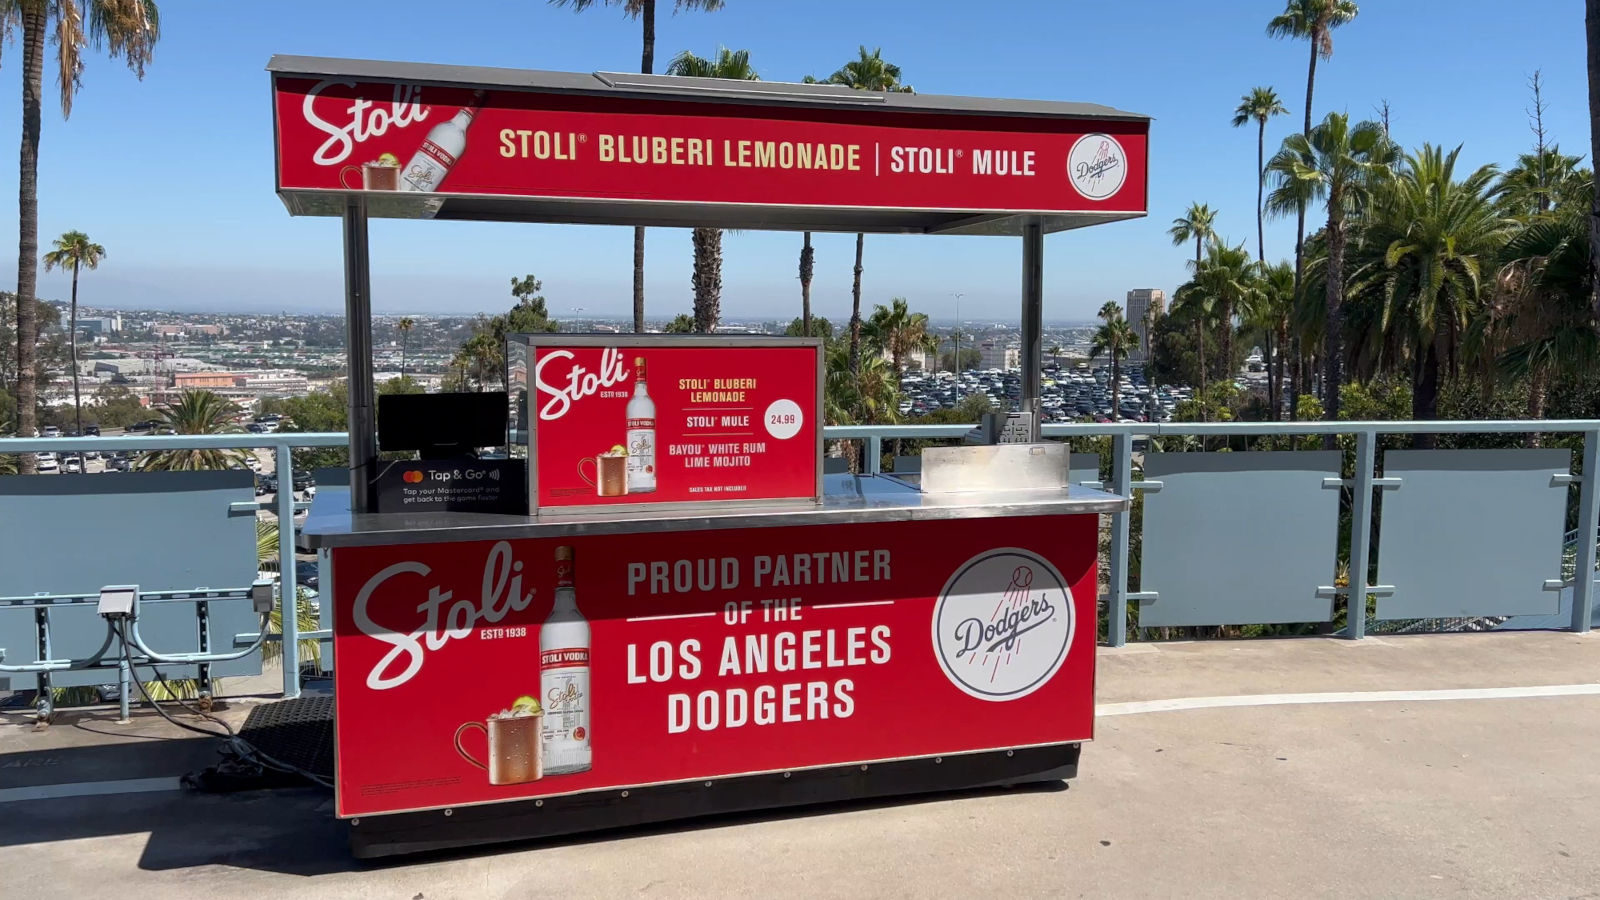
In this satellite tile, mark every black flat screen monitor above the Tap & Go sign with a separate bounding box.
[378,391,509,460]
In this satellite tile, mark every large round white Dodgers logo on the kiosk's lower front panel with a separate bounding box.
[933,548,1074,701]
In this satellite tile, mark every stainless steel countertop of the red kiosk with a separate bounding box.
[299,474,1128,549]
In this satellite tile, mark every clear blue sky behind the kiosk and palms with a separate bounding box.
[0,0,1589,320]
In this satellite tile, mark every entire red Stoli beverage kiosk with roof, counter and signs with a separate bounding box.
[278,56,1149,857]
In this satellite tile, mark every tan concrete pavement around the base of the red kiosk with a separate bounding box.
[0,633,1600,898]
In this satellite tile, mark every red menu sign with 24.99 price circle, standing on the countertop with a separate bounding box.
[524,335,822,509]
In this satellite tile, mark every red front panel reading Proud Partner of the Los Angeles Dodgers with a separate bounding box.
[324,516,1096,817]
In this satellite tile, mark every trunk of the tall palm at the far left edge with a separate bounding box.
[16,8,48,476]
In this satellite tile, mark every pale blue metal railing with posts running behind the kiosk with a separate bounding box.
[0,420,1600,697]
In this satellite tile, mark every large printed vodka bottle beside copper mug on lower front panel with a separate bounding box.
[539,546,594,775]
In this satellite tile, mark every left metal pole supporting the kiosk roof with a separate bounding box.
[344,197,378,512]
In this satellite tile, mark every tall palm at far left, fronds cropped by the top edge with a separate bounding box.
[0,0,160,474]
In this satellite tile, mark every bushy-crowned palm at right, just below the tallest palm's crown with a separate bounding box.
[1267,112,1398,421]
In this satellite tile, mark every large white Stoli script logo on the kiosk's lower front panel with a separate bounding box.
[350,541,533,690]
